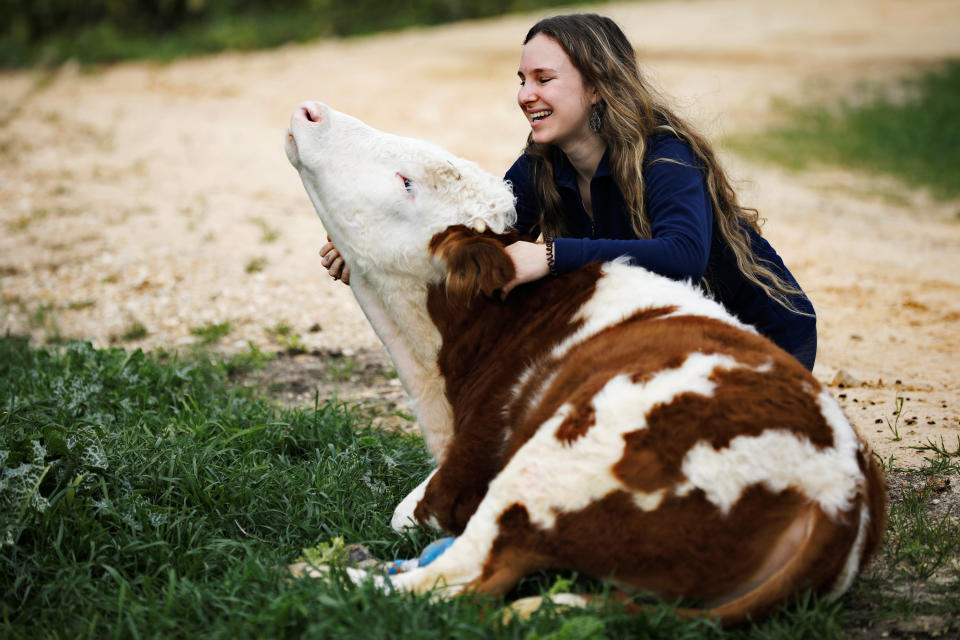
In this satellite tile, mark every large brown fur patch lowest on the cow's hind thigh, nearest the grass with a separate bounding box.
[484,486,855,601]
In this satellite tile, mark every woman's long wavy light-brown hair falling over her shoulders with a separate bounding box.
[523,13,807,315]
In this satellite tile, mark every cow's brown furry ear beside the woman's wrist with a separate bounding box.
[430,225,516,300]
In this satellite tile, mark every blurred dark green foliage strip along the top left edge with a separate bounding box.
[0,0,604,68]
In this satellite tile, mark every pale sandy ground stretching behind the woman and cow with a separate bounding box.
[0,0,960,465]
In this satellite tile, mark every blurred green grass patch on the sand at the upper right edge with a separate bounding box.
[725,60,960,199]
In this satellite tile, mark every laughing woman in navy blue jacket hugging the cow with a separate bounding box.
[321,14,817,369]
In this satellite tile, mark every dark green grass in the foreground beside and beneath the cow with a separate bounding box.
[0,336,956,640]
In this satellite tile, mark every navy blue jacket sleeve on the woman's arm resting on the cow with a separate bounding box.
[555,138,713,281]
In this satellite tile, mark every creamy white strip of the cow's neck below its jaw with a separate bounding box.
[350,274,453,463]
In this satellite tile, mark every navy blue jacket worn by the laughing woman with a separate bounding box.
[505,134,816,352]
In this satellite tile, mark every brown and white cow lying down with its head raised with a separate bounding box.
[286,102,886,624]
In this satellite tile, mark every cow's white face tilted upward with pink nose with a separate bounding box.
[286,102,516,281]
